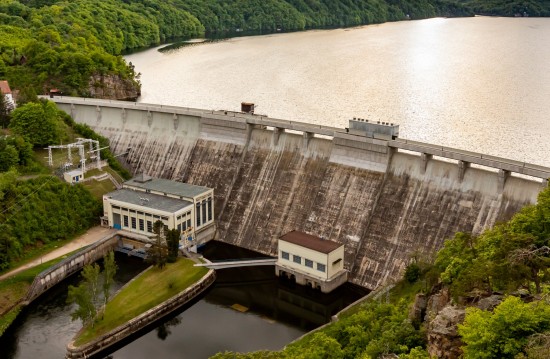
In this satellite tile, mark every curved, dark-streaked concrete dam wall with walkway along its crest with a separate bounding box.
[53,97,550,289]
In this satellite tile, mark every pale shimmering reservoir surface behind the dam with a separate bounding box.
[126,17,550,166]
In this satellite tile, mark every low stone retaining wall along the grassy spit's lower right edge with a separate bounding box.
[66,269,216,359]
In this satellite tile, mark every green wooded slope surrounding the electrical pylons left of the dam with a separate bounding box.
[0,100,130,271]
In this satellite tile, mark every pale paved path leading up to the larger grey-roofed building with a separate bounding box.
[0,226,116,280]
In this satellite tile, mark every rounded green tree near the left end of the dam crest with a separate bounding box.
[10,101,59,146]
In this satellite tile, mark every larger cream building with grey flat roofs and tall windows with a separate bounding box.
[102,174,215,246]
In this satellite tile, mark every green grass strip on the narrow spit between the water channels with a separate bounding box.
[75,258,208,345]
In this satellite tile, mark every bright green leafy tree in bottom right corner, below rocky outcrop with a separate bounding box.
[458,296,550,359]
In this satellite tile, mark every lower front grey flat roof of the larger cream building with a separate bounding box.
[105,188,193,213]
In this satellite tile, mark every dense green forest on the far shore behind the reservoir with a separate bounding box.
[0,0,550,102]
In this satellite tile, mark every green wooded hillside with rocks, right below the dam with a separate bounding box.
[214,187,550,359]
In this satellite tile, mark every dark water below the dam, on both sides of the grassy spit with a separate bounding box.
[0,242,367,359]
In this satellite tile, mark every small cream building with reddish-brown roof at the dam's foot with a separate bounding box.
[275,231,348,293]
